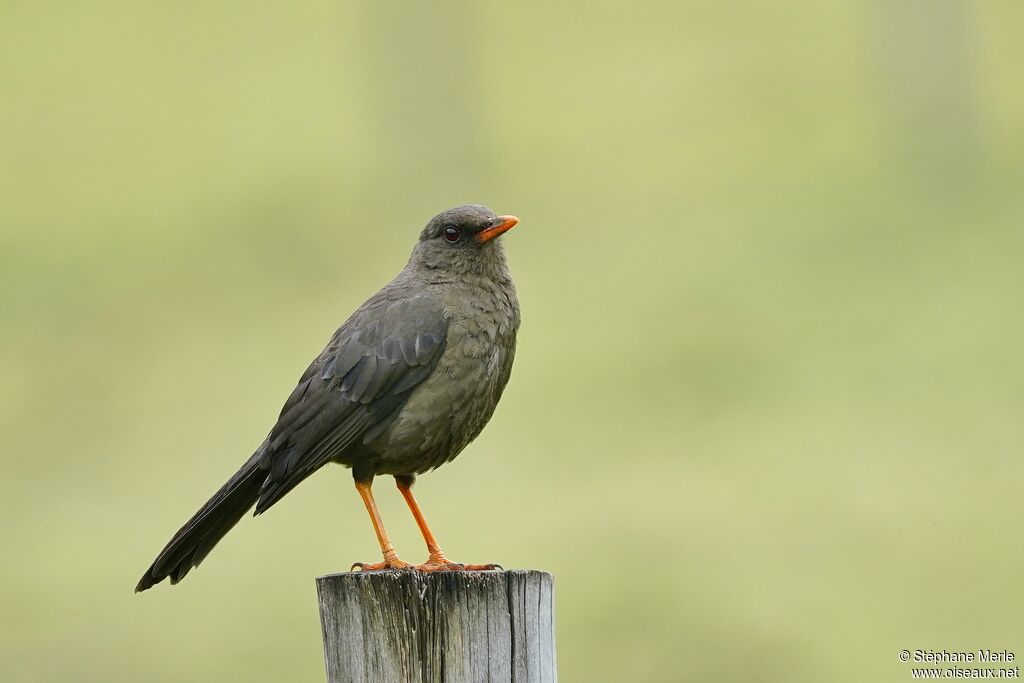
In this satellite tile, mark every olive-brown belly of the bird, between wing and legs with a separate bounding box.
[368,336,514,474]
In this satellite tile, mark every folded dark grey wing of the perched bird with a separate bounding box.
[250,292,447,514]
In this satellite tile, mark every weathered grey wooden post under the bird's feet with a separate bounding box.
[316,570,557,683]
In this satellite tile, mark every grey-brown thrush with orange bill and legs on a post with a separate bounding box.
[135,205,520,592]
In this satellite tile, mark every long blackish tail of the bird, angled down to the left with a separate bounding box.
[135,443,267,593]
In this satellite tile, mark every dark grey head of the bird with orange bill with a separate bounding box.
[413,204,519,274]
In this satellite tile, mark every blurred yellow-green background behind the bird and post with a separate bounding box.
[0,0,1024,682]
